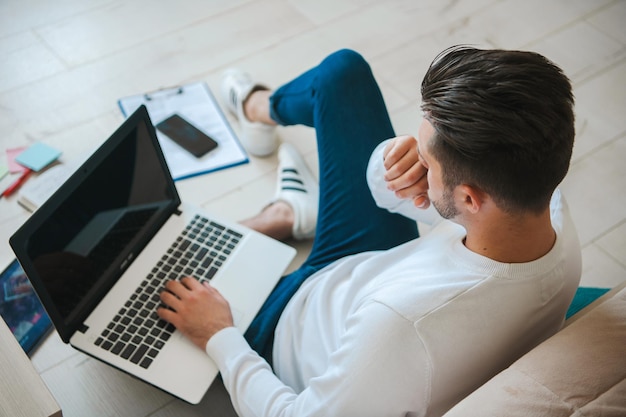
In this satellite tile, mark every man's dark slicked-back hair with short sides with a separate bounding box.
[422,46,575,213]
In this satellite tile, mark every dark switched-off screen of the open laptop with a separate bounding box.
[11,105,180,336]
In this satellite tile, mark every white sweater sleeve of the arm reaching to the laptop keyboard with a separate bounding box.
[207,302,430,417]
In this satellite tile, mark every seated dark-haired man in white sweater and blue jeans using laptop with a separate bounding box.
[159,47,580,417]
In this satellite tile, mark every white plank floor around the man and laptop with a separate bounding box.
[0,0,626,416]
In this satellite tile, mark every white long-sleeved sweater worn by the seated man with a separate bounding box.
[206,144,581,417]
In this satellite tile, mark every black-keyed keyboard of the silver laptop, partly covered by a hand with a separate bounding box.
[94,216,242,368]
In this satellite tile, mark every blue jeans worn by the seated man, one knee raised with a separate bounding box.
[245,50,418,363]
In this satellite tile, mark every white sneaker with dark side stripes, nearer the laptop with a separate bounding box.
[274,143,319,240]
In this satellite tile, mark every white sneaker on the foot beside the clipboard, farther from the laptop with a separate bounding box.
[221,69,278,156]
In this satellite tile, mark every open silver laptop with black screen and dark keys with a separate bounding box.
[10,106,295,404]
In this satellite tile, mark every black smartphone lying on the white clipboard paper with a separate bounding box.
[156,114,217,158]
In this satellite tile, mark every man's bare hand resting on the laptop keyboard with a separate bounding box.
[157,277,234,350]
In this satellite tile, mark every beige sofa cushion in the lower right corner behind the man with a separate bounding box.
[445,282,626,417]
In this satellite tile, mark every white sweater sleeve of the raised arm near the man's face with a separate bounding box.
[367,139,442,225]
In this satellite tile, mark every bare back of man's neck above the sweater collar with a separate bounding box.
[464,210,556,263]
